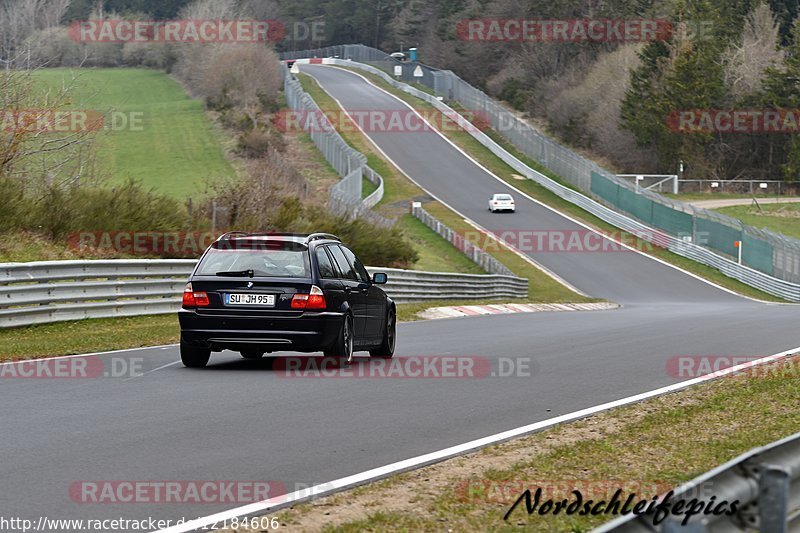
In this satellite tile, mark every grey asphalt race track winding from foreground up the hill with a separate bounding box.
[0,66,800,520]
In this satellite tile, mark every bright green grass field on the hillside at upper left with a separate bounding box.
[36,69,234,198]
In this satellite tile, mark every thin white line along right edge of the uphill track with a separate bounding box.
[315,66,788,305]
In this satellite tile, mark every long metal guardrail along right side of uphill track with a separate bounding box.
[304,59,800,302]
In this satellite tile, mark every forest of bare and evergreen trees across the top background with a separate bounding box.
[0,0,800,181]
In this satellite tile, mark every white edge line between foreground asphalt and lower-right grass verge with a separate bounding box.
[155,346,800,533]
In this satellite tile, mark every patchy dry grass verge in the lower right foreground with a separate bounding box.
[231,357,800,533]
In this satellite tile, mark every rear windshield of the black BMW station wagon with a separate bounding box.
[197,241,311,278]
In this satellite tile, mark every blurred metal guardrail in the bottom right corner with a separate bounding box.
[594,433,800,533]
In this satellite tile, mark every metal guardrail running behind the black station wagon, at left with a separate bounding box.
[0,259,528,328]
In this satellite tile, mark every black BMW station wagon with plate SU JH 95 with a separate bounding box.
[179,232,396,367]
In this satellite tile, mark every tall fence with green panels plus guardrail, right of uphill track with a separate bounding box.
[282,45,800,302]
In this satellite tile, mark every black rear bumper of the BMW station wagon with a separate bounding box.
[178,309,344,352]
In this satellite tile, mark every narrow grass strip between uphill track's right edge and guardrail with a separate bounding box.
[340,68,784,302]
